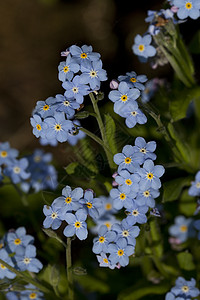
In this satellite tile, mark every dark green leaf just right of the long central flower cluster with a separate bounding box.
[163,177,192,202]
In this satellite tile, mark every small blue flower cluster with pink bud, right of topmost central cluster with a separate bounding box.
[108,72,147,128]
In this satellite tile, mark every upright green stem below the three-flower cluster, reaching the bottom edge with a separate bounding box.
[66,238,74,300]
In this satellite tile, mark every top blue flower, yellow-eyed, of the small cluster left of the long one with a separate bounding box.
[53,185,83,219]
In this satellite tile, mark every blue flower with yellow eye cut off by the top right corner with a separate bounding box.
[173,0,200,20]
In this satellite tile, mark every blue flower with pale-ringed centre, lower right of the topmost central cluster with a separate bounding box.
[80,59,108,91]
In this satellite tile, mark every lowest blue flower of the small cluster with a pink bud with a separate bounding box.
[119,101,147,128]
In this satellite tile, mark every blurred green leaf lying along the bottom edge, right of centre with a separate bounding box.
[117,282,170,300]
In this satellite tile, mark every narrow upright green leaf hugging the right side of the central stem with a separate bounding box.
[104,114,118,155]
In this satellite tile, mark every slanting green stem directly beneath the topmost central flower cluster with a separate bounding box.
[89,93,115,170]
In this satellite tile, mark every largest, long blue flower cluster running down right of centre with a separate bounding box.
[93,137,164,269]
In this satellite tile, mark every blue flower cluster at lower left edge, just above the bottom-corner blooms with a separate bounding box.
[0,227,43,279]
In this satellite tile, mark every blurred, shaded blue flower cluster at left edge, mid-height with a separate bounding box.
[0,142,57,193]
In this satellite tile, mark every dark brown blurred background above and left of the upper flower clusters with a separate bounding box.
[0,0,170,151]
